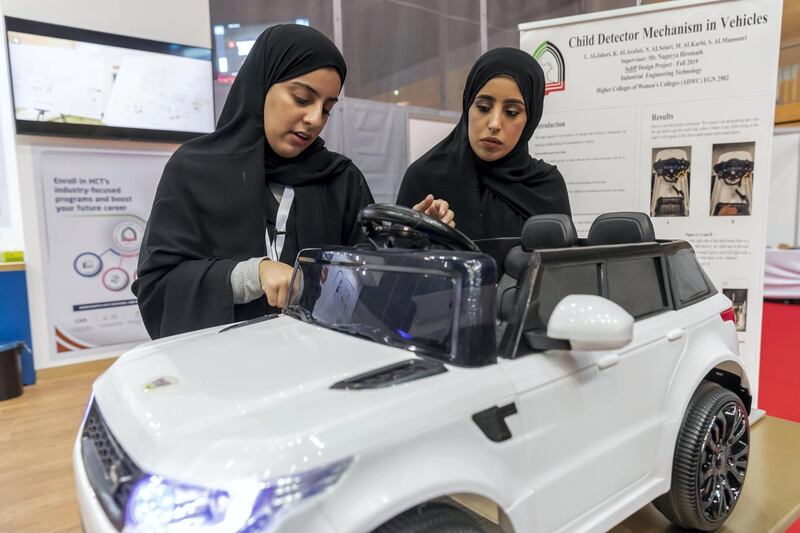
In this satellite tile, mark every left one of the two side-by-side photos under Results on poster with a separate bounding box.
[650,146,692,217]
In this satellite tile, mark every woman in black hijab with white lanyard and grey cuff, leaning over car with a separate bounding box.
[133,25,373,339]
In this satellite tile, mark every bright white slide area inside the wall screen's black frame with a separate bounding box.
[8,31,214,132]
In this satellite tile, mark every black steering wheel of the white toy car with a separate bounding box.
[356,204,480,252]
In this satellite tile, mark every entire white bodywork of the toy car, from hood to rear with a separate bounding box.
[74,251,747,533]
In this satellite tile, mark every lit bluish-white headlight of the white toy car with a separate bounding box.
[125,459,352,533]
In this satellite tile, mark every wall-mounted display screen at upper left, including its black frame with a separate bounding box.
[5,17,214,141]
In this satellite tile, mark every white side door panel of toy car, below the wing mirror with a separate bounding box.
[499,311,685,531]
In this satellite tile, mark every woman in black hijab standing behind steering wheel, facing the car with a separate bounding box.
[397,48,571,239]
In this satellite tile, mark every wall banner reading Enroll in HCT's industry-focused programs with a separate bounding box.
[36,149,170,361]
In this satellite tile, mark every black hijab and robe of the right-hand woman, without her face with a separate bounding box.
[397,48,571,239]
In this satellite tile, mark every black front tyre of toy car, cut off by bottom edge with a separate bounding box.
[373,503,483,533]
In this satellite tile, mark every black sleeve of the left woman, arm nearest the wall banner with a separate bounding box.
[132,157,238,339]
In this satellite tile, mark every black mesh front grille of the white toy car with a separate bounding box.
[81,403,144,529]
